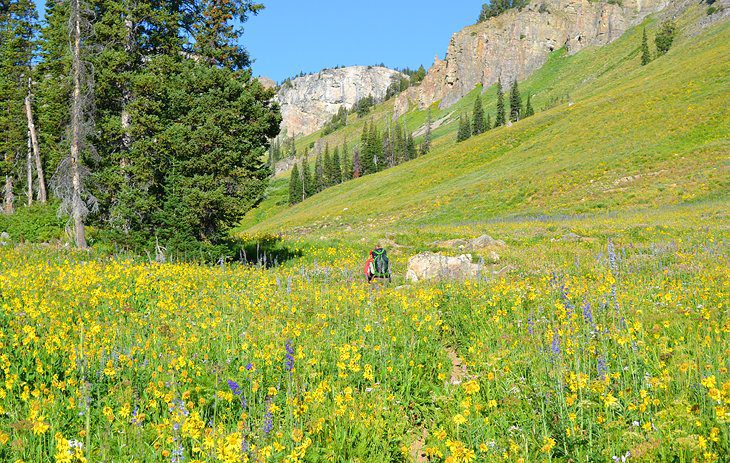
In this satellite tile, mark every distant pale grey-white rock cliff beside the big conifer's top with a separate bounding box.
[277,66,402,136]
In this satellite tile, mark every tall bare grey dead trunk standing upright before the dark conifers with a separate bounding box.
[69,0,87,249]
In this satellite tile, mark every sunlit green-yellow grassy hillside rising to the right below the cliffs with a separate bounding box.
[243,16,730,236]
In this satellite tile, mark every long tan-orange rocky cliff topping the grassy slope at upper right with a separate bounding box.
[395,0,669,115]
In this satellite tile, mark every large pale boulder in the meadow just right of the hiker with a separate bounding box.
[406,252,482,282]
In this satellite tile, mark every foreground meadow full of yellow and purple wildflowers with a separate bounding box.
[0,214,730,463]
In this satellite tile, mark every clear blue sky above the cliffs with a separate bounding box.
[38,0,484,81]
